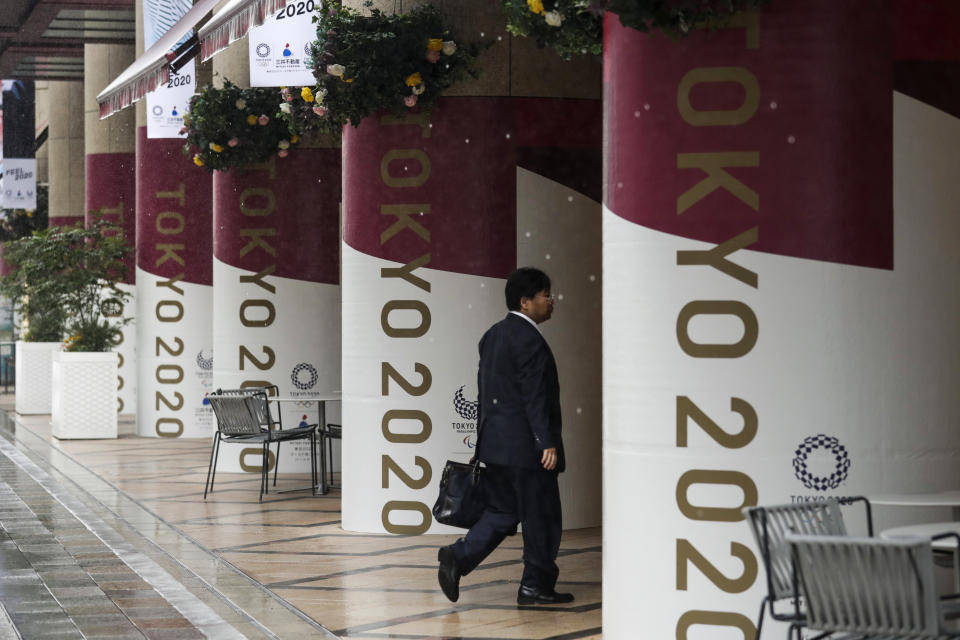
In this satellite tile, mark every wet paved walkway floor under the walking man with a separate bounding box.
[0,396,601,639]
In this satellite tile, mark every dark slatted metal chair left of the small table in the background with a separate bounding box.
[203,389,317,501]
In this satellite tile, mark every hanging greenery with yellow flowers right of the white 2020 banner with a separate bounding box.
[311,0,480,126]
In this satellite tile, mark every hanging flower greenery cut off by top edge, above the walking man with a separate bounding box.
[501,0,770,60]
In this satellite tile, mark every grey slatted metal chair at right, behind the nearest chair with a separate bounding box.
[743,497,873,640]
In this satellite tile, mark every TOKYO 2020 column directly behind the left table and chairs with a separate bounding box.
[213,25,341,474]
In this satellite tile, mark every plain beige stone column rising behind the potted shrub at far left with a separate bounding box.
[47,80,85,227]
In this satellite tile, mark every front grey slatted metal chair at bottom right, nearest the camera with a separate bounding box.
[787,533,960,640]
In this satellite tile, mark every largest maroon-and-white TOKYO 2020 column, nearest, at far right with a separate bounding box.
[603,0,960,638]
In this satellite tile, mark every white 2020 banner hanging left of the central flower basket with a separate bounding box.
[247,0,319,87]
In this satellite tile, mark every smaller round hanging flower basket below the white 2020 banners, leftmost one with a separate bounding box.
[183,80,297,172]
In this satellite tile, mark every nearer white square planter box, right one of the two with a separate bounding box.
[50,351,118,440]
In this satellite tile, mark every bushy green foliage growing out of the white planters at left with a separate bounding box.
[0,220,131,351]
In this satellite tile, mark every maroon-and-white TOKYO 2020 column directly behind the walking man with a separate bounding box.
[343,2,602,533]
